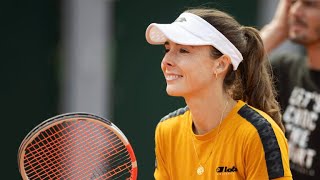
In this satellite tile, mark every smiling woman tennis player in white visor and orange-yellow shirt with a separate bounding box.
[146,9,292,180]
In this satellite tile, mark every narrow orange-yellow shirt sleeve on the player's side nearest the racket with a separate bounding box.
[154,122,169,180]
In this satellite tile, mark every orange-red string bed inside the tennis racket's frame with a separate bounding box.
[25,121,131,179]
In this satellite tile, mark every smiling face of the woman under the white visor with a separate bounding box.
[161,41,215,97]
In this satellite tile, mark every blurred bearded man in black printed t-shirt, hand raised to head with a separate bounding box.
[260,0,320,180]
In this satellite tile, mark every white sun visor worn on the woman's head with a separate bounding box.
[146,13,243,70]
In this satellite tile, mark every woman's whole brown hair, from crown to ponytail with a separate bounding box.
[186,8,284,131]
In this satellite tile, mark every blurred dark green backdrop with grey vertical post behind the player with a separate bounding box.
[0,0,295,180]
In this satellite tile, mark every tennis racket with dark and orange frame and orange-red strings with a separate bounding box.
[18,113,138,180]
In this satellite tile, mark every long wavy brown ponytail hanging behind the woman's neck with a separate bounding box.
[237,27,284,131]
